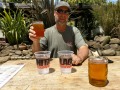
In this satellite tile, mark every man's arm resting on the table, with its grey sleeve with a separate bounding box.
[72,27,89,65]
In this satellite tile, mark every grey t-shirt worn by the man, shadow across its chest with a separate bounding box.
[40,25,86,58]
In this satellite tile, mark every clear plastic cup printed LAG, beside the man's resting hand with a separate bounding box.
[58,50,73,74]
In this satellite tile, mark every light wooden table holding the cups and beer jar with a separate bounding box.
[0,56,120,90]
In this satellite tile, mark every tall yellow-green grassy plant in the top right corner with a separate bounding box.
[93,1,120,36]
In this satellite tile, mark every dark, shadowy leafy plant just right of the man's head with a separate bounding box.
[70,3,98,40]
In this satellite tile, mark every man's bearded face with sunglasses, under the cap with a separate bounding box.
[54,6,69,24]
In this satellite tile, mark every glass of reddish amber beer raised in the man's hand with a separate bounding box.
[32,21,44,37]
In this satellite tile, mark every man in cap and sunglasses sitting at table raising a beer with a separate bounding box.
[29,1,89,65]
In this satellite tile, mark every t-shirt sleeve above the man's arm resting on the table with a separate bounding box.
[73,27,88,48]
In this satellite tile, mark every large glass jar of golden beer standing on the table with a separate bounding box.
[88,56,108,87]
